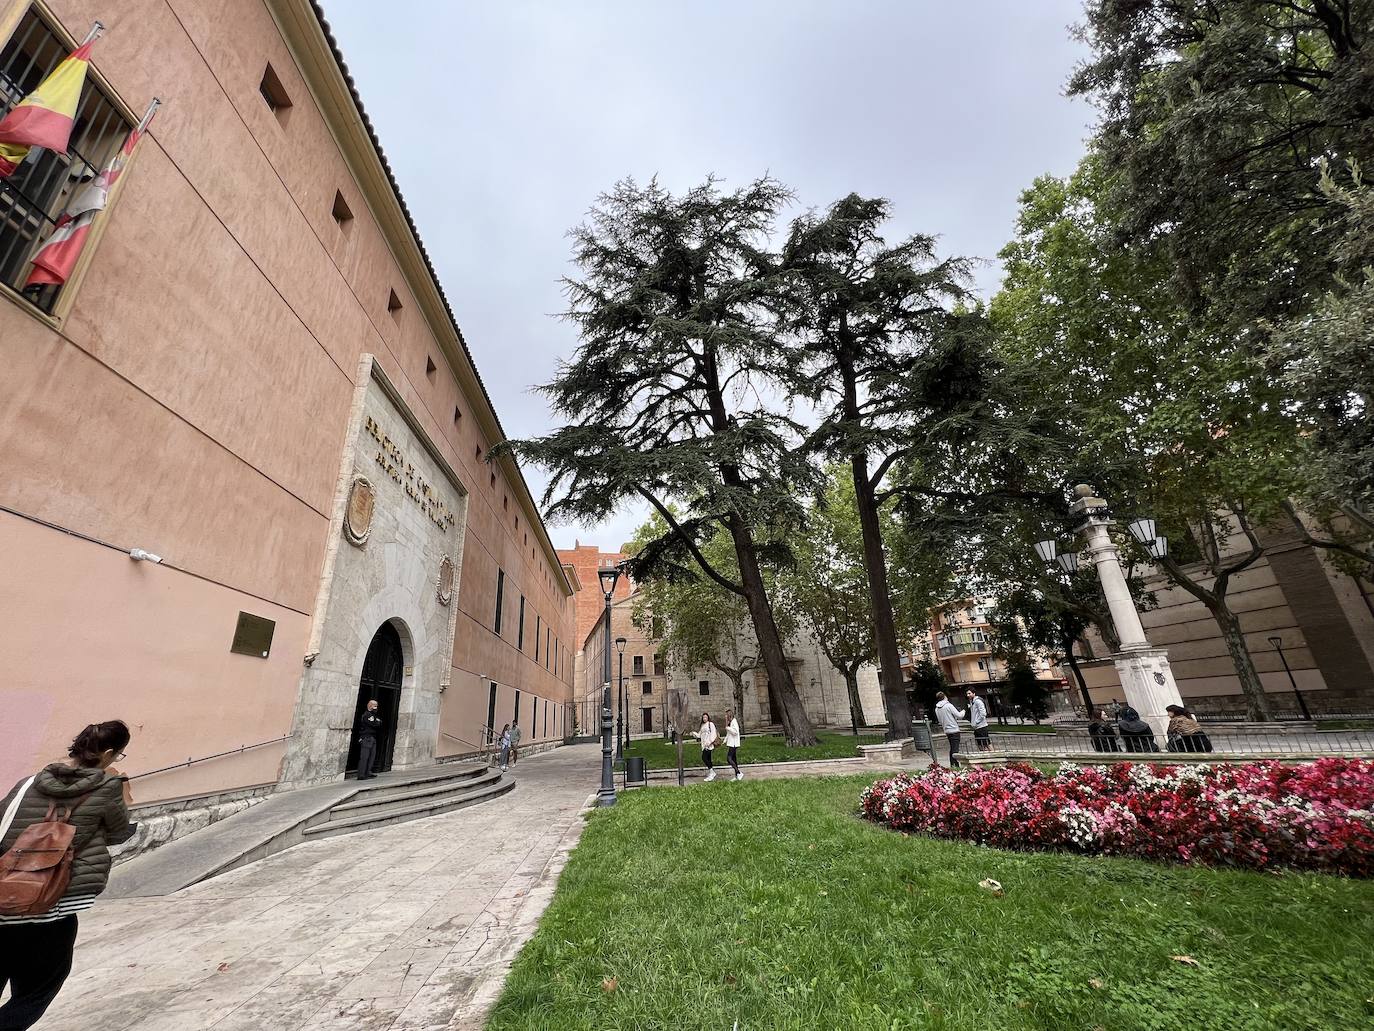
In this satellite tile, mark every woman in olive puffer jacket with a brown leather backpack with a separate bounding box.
[0,719,133,1031]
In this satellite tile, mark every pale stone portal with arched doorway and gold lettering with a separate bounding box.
[279,355,467,786]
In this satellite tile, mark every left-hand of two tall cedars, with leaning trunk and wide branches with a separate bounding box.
[508,179,816,745]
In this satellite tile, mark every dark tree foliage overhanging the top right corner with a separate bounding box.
[1070,0,1374,577]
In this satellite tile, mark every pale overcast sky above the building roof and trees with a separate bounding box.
[322,0,1092,548]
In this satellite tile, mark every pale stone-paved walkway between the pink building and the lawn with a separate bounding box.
[37,745,600,1031]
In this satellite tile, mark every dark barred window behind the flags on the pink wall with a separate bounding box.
[0,8,133,313]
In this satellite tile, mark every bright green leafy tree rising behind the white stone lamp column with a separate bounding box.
[992,165,1307,719]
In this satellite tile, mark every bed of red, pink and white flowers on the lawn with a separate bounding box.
[860,759,1374,877]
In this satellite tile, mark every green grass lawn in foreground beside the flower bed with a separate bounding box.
[488,777,1374,1031]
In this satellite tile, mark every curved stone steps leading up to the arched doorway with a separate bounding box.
[301,763,515,841]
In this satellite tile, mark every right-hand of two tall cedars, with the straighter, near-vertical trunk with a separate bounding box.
[782,194,969,738]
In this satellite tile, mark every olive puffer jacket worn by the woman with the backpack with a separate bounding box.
[0,763,133,898]
